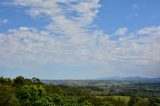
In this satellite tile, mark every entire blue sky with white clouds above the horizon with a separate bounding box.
[0,0,160,79]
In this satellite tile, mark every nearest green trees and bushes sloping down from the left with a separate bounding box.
[0,76,160,106]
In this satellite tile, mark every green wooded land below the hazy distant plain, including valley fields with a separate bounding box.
[0,76,160,106]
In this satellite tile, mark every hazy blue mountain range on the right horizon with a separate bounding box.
[97,76,160,82]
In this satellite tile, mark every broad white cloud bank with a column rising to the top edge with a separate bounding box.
[0,0,160,68]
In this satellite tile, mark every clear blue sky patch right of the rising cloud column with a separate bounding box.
[95,0,160,33]
